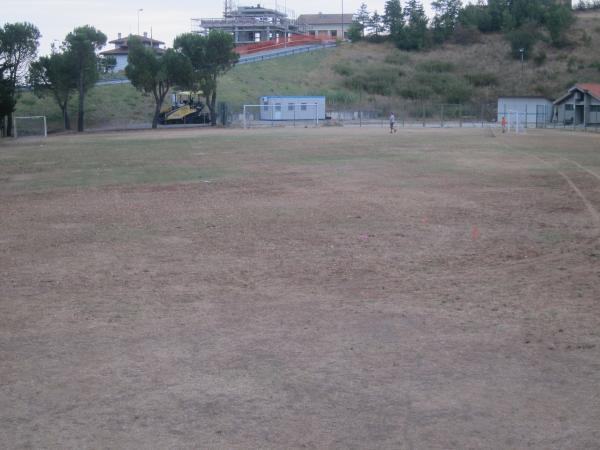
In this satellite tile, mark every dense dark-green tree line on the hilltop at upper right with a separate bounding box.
[348,0,574,54]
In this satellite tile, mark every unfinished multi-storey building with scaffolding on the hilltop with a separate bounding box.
[192,0,303,45]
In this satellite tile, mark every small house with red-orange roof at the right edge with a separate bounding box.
[553,83,600,127]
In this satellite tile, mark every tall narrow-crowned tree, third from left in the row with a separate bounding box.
[64,25,106,131]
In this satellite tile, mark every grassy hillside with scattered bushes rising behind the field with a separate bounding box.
[17,11,600,129]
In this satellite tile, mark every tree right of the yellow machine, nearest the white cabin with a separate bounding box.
[173,30,240,126]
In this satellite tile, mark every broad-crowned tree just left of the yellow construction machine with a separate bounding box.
[125,37,193,128]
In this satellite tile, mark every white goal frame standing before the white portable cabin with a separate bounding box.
[241,103,319,128]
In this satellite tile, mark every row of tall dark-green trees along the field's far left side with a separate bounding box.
[0,22,239,136]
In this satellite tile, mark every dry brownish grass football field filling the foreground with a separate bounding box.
[0,128,600,450]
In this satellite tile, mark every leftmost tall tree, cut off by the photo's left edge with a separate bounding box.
[0,22,41,136]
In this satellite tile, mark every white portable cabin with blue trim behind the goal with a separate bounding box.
[260,96,325,121]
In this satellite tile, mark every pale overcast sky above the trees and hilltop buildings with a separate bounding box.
[0,0,404,54]
